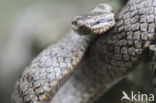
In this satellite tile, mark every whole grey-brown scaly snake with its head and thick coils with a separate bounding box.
[12,0,156,103]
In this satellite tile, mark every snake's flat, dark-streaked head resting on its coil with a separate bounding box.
[72,4,115,35]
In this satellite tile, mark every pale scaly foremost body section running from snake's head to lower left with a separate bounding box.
[14,32,91,103]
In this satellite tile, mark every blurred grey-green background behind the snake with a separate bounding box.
[0,0,152,103]
